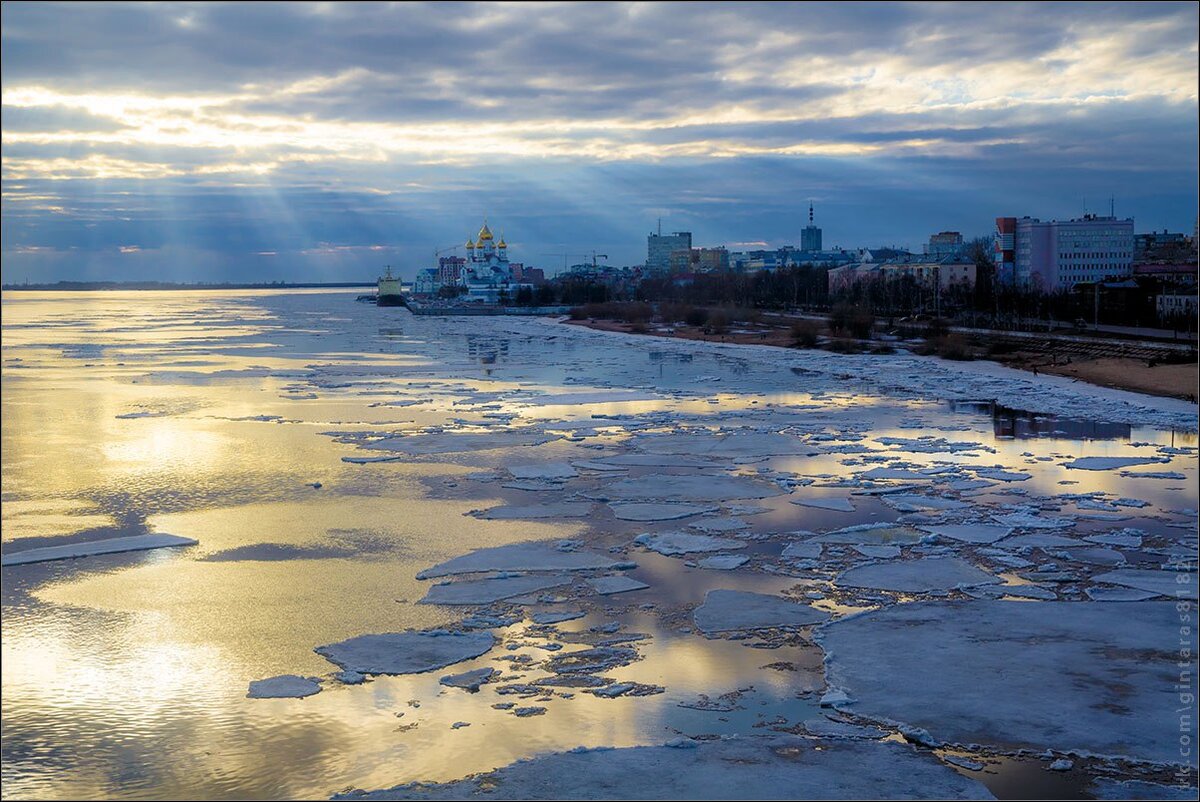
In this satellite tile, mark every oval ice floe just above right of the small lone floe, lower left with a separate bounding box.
[313,629,496,674]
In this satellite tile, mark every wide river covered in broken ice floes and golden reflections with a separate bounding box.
[2,292,1198,798]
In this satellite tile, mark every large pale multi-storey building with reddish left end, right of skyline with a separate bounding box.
[996,215,1133,292]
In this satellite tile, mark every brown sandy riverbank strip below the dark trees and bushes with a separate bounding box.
[564,319,1200,402]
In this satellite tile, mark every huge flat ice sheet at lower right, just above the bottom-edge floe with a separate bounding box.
[816,600,1195,765]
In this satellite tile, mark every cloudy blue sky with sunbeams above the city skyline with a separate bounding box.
[0,2,1200,282]
